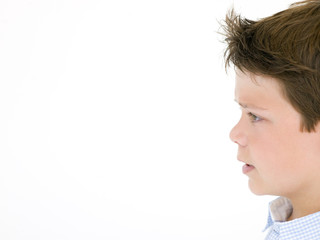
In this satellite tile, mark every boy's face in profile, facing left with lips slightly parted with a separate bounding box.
[230,70,320,198]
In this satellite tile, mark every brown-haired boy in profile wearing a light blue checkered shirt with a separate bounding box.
[224,0,320,240]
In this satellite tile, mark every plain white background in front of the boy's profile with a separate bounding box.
[0,0,291,240]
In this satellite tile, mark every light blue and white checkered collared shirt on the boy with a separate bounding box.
[265,197,320,240]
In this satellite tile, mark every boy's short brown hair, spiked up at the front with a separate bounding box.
[223,0,320,132]
